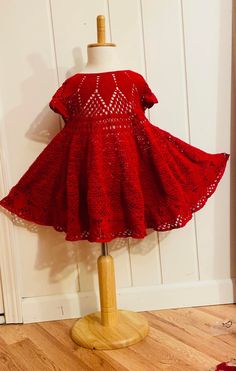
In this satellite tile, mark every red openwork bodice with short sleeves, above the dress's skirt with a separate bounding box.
[49,70,158,122]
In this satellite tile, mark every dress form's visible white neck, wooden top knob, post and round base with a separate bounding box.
[71,15,149,350]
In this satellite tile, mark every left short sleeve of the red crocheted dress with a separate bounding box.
[49,81,69,121]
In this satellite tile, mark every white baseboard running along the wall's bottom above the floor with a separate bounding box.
[22,278,236,323]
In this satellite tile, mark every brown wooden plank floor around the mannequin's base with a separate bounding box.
[0,304,236,371]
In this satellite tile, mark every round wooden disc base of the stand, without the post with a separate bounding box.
[71,310,149,350]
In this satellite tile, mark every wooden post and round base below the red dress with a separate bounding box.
[71,242,149,350]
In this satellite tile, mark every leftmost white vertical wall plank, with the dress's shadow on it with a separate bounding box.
[0,0,77,297]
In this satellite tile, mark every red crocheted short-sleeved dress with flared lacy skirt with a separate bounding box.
[0,70,230,242]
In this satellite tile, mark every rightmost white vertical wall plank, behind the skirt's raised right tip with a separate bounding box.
[183,0,232,279]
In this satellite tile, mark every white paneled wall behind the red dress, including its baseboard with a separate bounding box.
[0,0,233,322]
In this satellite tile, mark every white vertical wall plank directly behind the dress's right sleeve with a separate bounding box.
[142,0,198,283]
